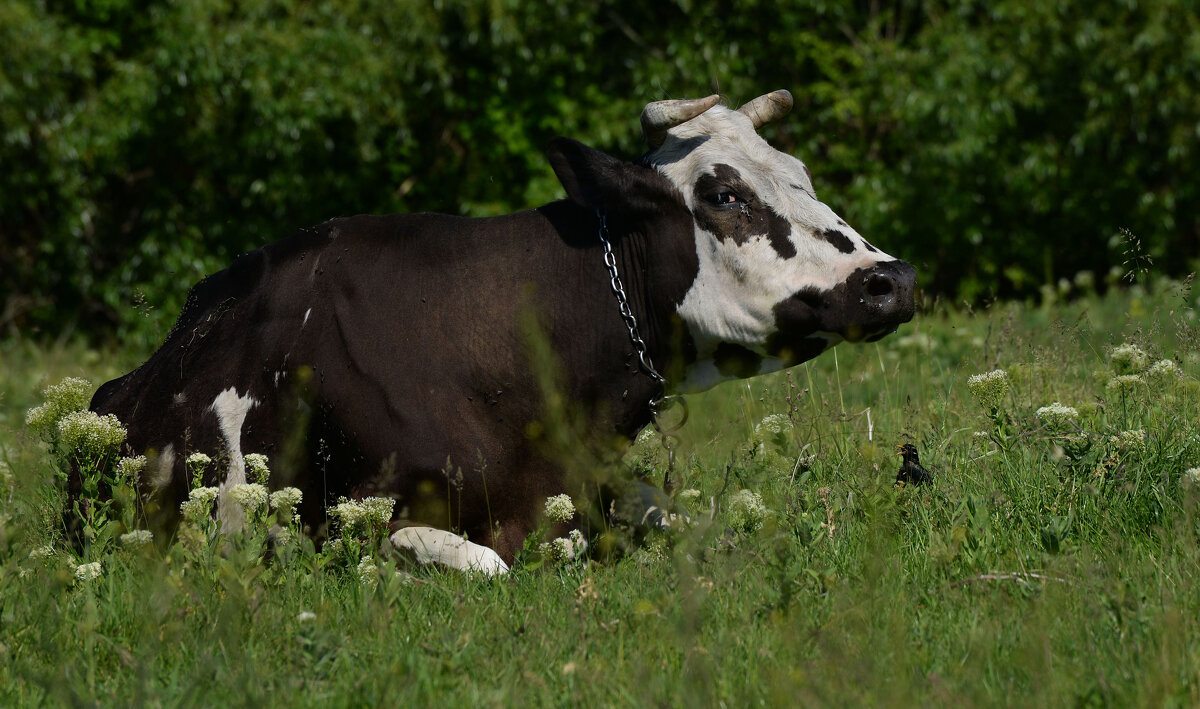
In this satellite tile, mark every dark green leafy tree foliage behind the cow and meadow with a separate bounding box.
[0,0,1200,335]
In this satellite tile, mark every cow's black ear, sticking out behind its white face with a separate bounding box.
[546,138,683,215]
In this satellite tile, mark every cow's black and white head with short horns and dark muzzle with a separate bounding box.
[551,91,916,389]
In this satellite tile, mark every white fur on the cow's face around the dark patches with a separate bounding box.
[649,106,894,389]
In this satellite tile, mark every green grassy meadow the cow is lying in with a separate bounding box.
[0,283,1200,707]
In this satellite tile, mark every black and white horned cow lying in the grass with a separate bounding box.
[70,91,916,575]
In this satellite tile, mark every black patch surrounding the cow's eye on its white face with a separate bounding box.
[692,164,796,259]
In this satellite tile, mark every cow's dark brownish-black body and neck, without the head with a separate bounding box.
[92,191,691,558]
